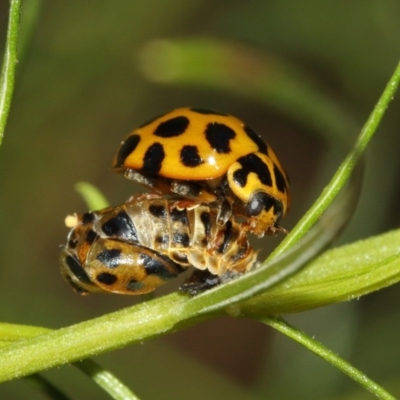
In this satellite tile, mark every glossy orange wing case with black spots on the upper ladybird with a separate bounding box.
[114,108,259,180]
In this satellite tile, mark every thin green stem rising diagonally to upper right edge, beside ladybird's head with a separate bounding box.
[270,63,400,257]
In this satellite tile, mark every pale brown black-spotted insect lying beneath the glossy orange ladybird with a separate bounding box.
[60,194,256,294]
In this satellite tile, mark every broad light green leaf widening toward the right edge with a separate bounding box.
[240,230,400,316]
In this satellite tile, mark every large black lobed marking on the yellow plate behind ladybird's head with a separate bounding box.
[233,153,272,187]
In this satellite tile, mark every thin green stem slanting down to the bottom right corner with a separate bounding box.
[259,317,395,400]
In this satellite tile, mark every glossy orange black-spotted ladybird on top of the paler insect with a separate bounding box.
[113,108,290,237]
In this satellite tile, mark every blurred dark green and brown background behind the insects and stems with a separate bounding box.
[0,0,400,400]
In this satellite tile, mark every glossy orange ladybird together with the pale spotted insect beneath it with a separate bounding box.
[61,108,290,294]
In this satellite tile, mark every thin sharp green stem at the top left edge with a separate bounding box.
[0,0,21,146]
